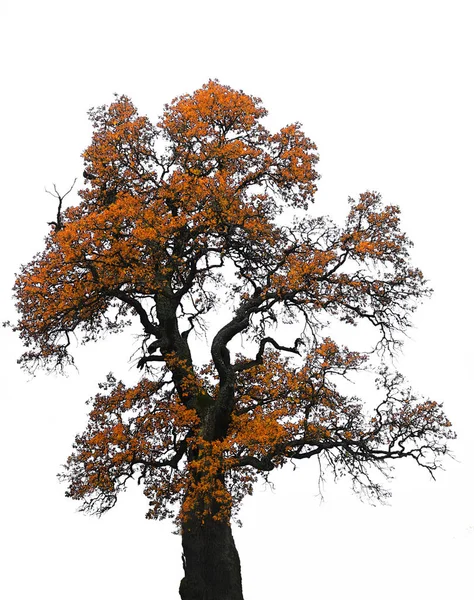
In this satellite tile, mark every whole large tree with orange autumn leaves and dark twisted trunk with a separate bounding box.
[15,81,454,600]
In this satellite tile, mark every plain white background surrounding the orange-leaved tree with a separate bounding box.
[0,0,474,600]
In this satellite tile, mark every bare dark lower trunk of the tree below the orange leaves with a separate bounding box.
[179,519,243,600]
